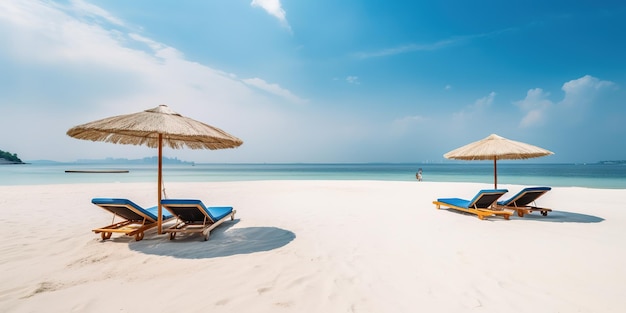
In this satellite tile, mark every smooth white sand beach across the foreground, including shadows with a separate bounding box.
[0,181,626,313]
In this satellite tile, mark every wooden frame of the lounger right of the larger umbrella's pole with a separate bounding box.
[161,199,237,241]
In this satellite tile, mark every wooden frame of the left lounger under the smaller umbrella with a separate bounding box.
[433,189,513,220]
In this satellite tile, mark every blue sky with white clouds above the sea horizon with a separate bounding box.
[0,0,626,163]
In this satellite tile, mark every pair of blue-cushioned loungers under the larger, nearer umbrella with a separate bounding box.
[91,198,237,241]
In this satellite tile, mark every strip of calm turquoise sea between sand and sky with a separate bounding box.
[0,161,626,189]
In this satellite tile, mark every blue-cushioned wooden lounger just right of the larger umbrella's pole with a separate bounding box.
[161,199,237,240]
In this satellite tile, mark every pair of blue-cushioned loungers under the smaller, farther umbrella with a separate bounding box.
[433,187,552,220]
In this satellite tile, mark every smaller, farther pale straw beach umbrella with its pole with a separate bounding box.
[443,134,554,189]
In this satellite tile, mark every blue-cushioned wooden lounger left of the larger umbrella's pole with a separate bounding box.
[91,198,173,241]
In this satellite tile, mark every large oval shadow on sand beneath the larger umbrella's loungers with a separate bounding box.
[129,219,296,259]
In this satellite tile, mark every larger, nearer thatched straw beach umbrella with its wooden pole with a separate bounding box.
[67,104,243,234]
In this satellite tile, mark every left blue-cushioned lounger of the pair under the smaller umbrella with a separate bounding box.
[433,189,513,220]
